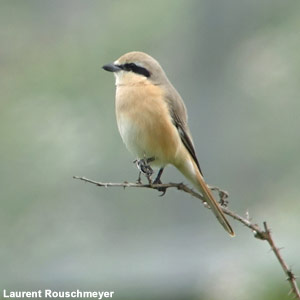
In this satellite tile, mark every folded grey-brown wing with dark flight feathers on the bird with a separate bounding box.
[166,86,203,176]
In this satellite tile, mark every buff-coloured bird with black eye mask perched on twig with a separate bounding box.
[102,51,235,236]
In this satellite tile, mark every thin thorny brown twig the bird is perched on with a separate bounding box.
[73,176,300,299]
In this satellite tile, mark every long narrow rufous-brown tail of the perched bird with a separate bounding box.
[177,159,235,236]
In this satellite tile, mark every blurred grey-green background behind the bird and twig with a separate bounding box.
[0,0,300,300]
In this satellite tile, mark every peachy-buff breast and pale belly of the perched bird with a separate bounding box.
[116,85,180,165]
